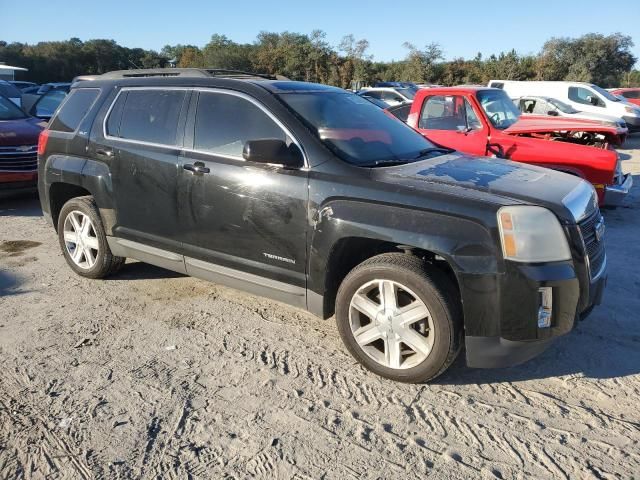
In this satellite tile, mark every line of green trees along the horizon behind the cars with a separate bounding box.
[0,30,640,88]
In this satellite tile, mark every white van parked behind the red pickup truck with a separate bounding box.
[488,80,640,132]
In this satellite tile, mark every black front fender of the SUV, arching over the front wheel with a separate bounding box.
[307,202,498,318]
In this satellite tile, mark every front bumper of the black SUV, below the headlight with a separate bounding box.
[463,255,607,368]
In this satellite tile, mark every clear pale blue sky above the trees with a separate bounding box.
[0,0,640,64]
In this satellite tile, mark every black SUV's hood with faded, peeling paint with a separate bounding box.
[373,152,593,222]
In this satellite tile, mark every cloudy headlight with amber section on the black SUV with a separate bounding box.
[498,205,571,263]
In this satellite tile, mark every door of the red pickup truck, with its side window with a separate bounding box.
[418,95,488,155]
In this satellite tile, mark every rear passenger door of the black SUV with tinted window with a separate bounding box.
[93,88,190,252]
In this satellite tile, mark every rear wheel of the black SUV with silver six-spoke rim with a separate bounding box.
[58,196,126,278]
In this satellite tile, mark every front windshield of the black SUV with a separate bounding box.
[279,92,447,166]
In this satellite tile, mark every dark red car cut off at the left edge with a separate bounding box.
[0,96,45,196]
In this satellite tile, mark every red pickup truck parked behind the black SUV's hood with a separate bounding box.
[407,87,633,206]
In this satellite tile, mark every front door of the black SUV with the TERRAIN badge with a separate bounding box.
[178,89,308,294]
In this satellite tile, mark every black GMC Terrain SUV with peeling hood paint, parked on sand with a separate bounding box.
[39,69,606,382]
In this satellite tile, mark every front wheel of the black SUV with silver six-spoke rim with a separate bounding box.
[336,253,462,383]
